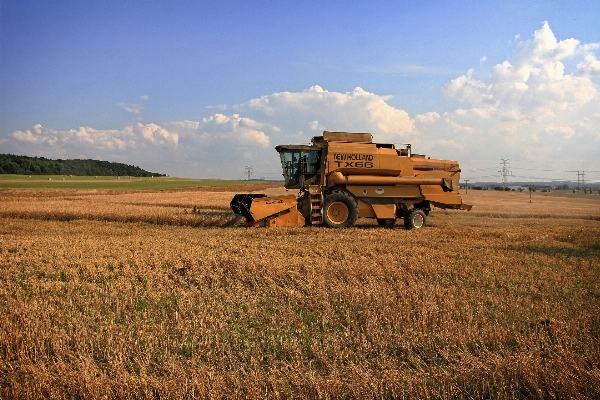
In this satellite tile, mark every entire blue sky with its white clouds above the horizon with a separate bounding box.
[0,0,600,180]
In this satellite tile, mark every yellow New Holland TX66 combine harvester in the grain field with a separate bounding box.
[231,132,471,229]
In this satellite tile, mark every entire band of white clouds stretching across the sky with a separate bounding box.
[3,23,600,179]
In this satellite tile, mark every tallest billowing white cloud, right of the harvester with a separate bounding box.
[436,22,600,173]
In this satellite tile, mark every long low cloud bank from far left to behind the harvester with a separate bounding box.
[12,85,422,177]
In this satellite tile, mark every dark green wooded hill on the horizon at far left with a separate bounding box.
[0,154,166,177]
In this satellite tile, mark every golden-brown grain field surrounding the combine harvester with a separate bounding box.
[0,188,600,399]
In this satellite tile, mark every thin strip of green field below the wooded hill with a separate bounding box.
[0,174,272,190]
